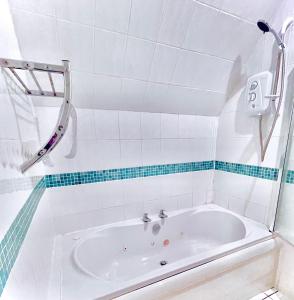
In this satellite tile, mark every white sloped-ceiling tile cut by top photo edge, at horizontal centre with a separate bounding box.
[129,0,164,41]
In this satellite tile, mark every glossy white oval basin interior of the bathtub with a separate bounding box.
[73,210,246,281]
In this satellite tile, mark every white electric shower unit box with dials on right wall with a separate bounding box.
[245,71,273,116]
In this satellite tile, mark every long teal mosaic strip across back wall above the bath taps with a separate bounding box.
[45,161,214,188]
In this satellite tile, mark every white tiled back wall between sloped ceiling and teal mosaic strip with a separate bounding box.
[31,107,217,174]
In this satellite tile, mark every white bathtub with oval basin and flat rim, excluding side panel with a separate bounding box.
[54,204,271,300]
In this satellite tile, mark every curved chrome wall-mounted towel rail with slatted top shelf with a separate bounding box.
[0,58,72,173]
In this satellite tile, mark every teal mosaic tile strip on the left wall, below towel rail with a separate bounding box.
[0,178,46,296]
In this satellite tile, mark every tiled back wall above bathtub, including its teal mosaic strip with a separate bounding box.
[37,107,217,236]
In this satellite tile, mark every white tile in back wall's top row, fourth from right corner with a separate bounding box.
[141,113,161,139]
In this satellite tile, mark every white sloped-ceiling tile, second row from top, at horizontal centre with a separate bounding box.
[124,36,155,80]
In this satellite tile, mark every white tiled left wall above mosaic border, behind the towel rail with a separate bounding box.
[0,0,40,247]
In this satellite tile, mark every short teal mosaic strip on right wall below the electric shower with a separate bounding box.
[215,161,279,180]
